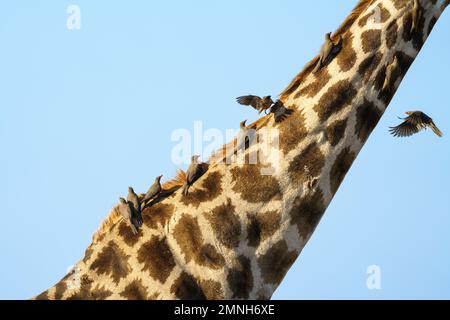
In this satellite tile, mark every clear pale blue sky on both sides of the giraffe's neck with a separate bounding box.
[0,0,450,299]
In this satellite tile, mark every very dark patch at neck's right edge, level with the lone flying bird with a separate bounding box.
[355,99,382,142]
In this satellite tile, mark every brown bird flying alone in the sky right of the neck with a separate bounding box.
[389,111,442,137]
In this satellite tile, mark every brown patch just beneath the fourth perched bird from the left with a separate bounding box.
[180,171,222,207]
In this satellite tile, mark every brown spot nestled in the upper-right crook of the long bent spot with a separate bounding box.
[204,198,241,249]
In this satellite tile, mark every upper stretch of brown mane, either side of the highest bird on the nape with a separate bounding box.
[280,0,374,101]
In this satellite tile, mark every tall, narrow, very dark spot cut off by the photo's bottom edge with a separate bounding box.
[227,255,253,299]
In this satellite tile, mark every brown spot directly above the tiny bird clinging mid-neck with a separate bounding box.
[288,142,325,183]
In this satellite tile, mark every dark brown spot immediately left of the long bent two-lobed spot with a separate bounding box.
[137,236,175,283]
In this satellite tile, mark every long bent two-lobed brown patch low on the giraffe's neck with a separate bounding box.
[173,215,225,269]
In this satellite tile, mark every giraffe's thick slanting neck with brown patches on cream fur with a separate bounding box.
[37,0,448,299]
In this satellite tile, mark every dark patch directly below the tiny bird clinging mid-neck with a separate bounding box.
[290,189,326,239]
